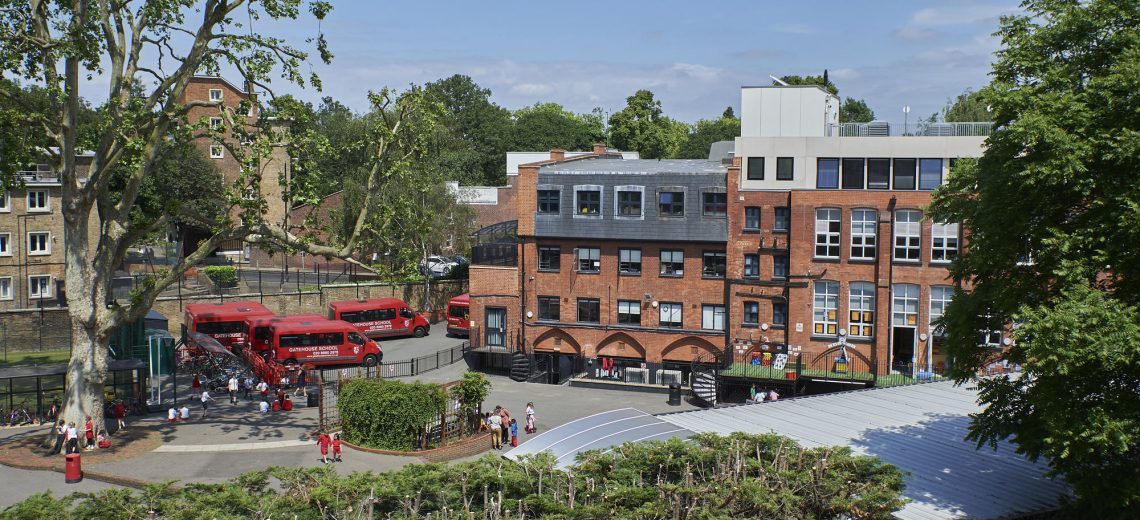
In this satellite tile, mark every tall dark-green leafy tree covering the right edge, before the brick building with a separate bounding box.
[931,0,1140,510]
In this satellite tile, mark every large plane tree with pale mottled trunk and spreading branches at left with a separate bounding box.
[0,0,441,435]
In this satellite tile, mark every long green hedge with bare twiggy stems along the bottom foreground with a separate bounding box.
[8,434,903,520]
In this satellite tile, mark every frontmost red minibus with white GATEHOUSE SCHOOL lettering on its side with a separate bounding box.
[270,319,384,366]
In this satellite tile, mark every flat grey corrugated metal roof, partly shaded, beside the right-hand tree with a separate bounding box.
[658,382,1068,519]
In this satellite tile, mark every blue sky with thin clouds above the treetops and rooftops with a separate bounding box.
[262,0,1017,122]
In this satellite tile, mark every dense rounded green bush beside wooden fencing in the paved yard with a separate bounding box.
[336,379,447,450]
